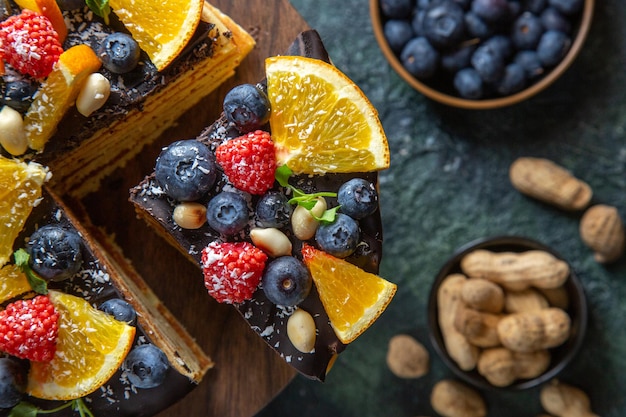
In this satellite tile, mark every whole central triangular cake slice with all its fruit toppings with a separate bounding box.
[130,31,396,380]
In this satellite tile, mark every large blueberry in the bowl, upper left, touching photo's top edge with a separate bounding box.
[423,0,465,48]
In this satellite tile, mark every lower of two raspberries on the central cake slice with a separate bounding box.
[202,242,267,304]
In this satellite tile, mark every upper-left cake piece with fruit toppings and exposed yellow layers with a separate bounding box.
[0,0,254,197]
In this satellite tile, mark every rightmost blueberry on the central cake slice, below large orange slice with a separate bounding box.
[337,178,378,219]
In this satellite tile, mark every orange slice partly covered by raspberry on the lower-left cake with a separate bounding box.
[26,291,135,400]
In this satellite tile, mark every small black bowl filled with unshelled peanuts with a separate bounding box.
[428,236,588,390]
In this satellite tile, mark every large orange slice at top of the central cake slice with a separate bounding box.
[265,56,389,174]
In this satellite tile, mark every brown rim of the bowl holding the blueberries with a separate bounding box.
[370,0,595,110]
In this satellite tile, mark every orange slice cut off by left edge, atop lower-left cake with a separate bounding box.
[0,156,48,266]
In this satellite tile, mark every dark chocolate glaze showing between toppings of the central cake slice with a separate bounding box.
[130,31,392,380]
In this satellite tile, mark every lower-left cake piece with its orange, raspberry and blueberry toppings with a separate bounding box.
[0,157,213,416]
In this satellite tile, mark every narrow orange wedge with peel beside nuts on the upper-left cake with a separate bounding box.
[24,45,101,151]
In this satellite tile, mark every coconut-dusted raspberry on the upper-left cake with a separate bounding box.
[0,9,63,78]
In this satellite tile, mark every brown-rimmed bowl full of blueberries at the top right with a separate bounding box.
[370,0,595,109]
